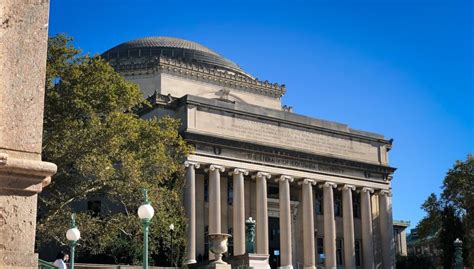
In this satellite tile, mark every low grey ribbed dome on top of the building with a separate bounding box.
[102,37,249,76]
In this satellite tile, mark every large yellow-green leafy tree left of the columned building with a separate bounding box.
[37,35,191,265]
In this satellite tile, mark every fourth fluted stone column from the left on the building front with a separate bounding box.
[255,172,271,255]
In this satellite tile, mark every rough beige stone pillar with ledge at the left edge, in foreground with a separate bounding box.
[0,0,56,268]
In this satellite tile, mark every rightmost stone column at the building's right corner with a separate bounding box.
[379,190,395,269]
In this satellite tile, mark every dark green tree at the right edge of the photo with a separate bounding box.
[417,154,474,268]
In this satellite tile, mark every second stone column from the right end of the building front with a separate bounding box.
[360,187,375,269]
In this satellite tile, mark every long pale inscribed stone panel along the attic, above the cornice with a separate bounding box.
[188,110,379,163]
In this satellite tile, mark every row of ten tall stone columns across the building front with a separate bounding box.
[184,161,394,269]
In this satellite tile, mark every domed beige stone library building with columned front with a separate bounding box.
[103,38,395,268]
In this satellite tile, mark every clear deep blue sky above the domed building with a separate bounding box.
[49,0,474,228]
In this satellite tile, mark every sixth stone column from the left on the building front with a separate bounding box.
[298,178,316,269]
